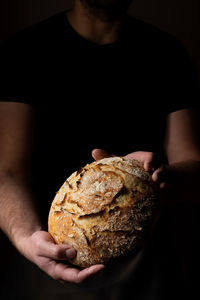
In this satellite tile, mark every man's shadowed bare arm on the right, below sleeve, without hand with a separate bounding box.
[163,109,200,206]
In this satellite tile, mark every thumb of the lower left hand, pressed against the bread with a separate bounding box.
[37,239,76,260]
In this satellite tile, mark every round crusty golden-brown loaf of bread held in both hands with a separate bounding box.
[48,157,158,267]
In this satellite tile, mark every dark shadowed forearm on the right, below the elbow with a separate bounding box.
[163,160,200,205]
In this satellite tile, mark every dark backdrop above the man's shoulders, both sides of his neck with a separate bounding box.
[0,0,200,79]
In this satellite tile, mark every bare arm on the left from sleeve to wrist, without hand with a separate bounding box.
[0,103,41,247]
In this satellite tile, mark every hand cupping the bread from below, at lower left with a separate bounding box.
[21,231,104,283]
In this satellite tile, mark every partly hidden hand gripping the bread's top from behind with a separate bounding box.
[92,149,167,189]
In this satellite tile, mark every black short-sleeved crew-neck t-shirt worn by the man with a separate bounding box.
[0,11,198,299]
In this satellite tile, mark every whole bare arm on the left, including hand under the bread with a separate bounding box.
[0,102,104,283]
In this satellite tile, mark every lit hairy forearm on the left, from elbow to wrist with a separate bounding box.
[0,172,42,252]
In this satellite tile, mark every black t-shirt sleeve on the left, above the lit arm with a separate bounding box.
[0,30,32,104]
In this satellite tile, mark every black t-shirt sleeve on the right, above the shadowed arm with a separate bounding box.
[163,38,200,114]
